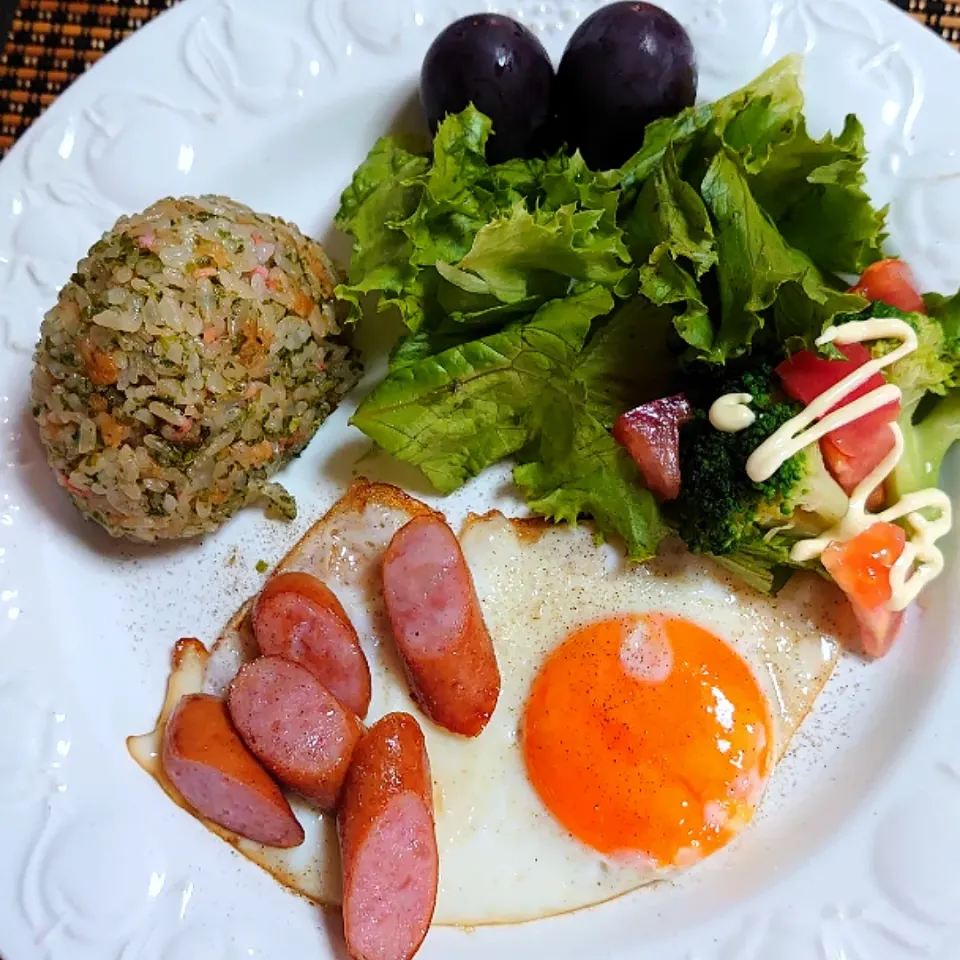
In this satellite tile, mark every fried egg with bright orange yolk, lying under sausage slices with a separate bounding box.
[129,481,848,926]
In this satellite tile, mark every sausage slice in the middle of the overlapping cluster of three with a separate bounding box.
[227,657,363,810]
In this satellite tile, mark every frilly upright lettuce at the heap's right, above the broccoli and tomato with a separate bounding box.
[620,57,885,363]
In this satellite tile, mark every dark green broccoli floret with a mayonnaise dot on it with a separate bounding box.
[672,363,849,576]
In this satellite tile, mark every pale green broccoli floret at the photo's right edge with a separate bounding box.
[862,294,960,498]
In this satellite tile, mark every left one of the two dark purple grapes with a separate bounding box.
[420,13,554,163]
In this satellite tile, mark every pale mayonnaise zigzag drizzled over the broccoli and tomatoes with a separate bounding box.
[711,317,953,611]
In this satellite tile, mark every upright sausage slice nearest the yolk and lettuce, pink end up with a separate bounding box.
[383,515,500,737]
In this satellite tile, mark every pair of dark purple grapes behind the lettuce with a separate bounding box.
[420,0,697,170]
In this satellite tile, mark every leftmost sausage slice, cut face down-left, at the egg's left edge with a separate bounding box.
[160,693,303,847]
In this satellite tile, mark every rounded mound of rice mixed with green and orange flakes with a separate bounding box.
[32,196,358,541]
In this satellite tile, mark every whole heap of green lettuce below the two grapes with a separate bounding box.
[337,57,885,560]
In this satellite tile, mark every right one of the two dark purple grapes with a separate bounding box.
[554,0,697,170]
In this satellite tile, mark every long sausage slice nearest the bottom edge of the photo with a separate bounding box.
[337,713,439,960]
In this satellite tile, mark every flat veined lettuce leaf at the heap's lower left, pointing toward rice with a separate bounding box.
[351,287,613,493]
